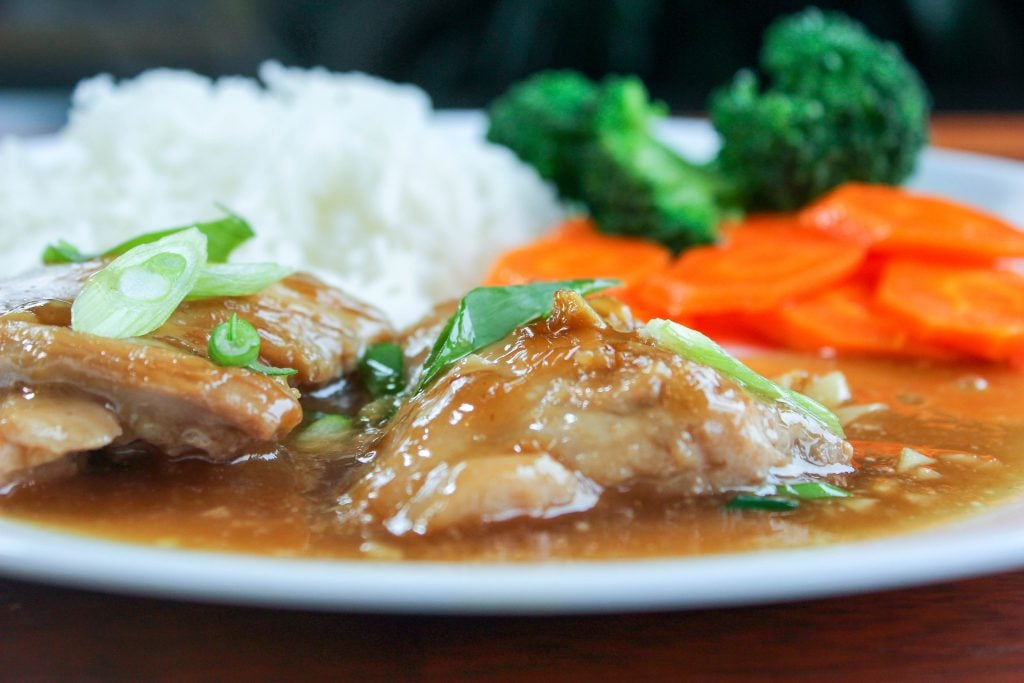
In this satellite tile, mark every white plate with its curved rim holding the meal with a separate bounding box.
[0,115,1024,613]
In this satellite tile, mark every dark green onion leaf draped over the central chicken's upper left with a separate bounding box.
[417,280,620,391]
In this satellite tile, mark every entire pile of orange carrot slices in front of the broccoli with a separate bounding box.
[487,189,1024,369]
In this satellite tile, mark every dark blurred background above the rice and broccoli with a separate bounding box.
[0,0,1024,130]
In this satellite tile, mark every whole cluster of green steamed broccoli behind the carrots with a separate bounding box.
[487,9,929,250]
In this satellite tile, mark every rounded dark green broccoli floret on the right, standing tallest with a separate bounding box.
[711,8,929,210]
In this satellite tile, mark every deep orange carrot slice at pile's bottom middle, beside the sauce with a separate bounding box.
[751,279,953,357]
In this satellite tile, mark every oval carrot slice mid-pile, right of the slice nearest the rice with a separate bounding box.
[637,216,864,316]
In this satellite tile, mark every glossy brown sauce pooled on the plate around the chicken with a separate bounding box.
[0,354,1024,561]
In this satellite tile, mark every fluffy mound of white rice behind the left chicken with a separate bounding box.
[0,63,561,325]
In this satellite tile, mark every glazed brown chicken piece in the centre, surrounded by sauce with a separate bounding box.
[339,292,852,536]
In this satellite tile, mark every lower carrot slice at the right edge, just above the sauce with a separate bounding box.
[877,259,1024,360]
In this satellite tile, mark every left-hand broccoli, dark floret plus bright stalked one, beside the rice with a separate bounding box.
[487,72,724,250]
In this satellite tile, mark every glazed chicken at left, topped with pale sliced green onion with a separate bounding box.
[0,264,388,481]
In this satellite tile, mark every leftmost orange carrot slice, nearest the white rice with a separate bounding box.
[485,218,672,285]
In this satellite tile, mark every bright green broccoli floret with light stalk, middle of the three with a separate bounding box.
[580,78,723,251]
